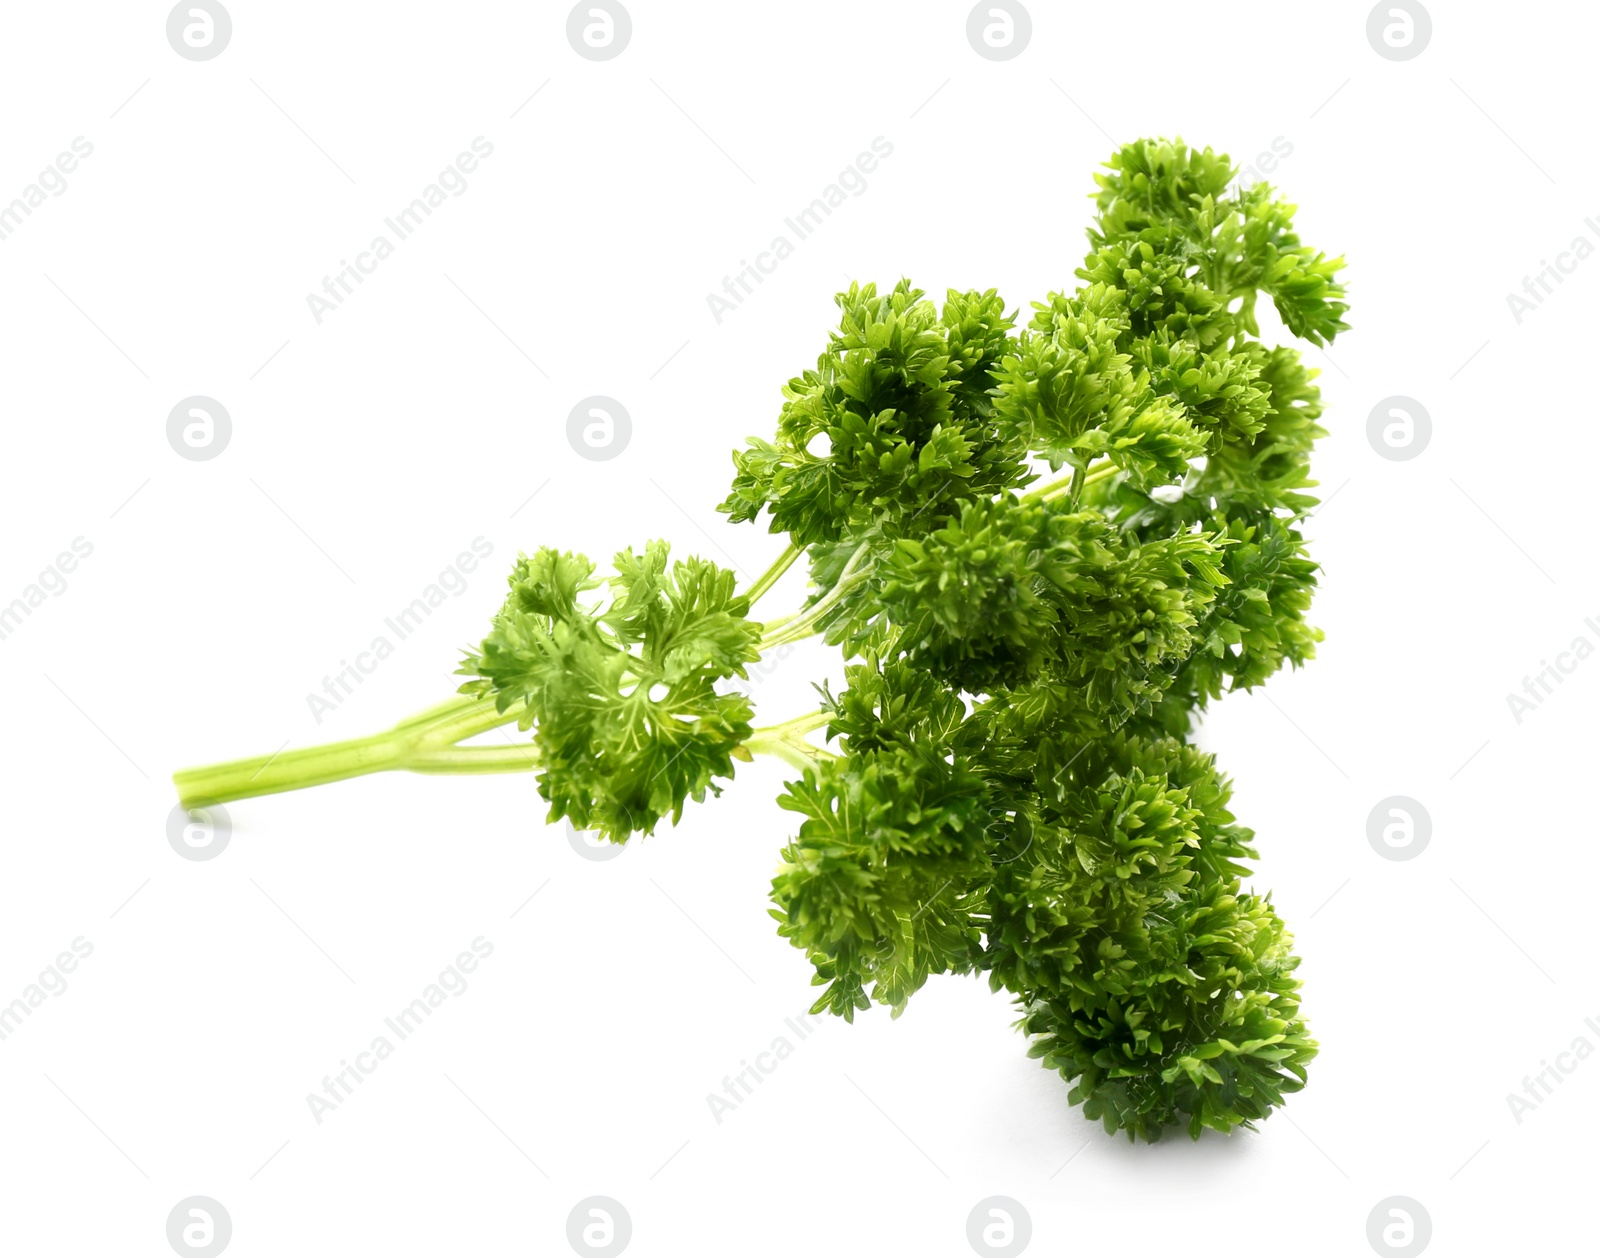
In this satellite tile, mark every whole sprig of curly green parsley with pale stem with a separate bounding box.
[176,141,1346,1140]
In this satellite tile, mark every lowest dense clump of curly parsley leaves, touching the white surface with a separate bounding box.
[989,736,1315,1138]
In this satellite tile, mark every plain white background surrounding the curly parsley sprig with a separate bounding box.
[0,0,1600,1258]
